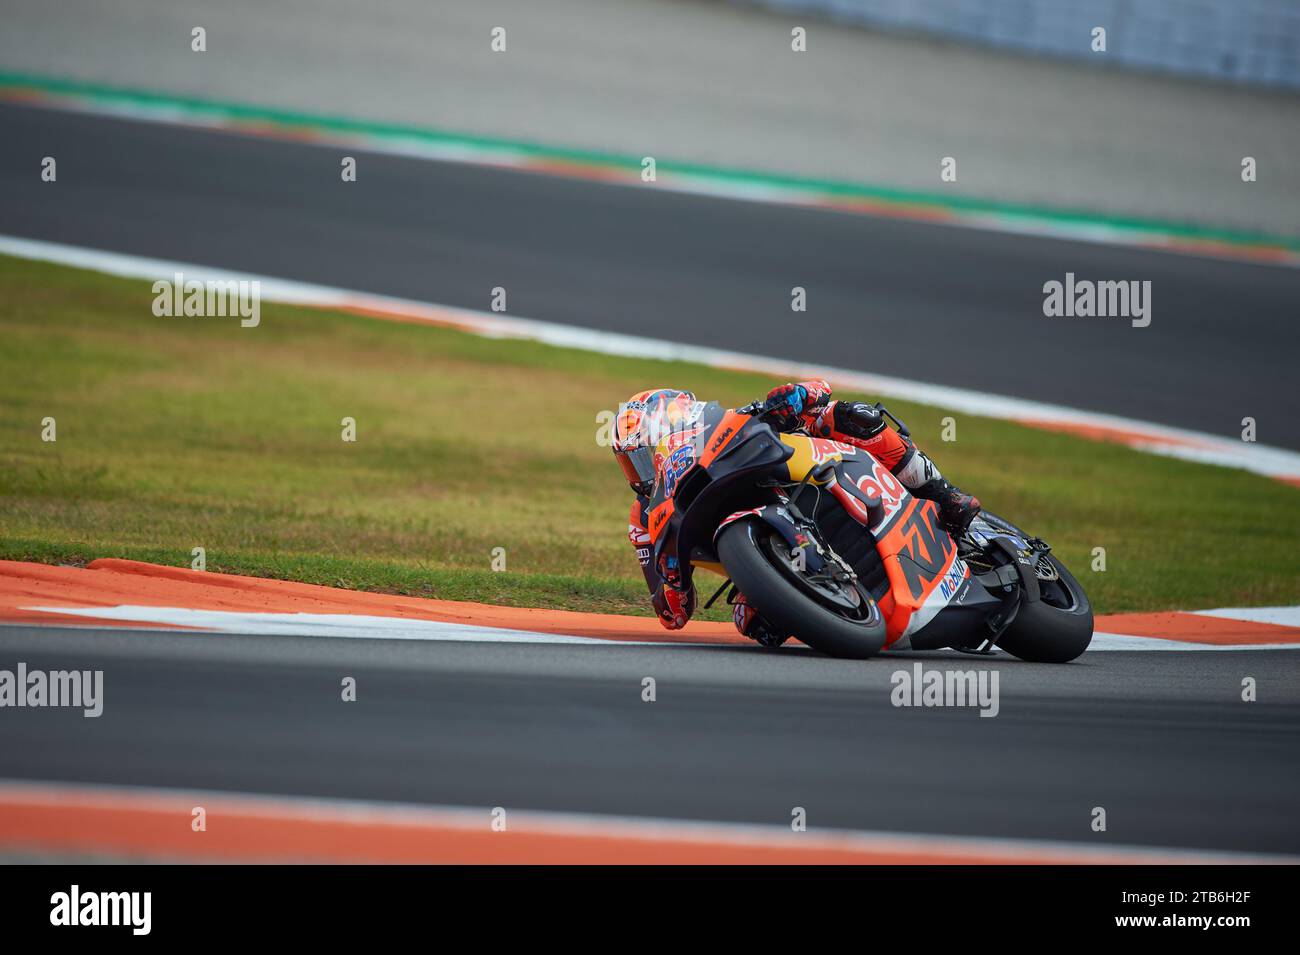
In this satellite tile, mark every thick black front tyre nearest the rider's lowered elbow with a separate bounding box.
[718,520,885,660]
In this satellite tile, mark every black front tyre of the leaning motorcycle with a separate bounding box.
[718,520,885,660]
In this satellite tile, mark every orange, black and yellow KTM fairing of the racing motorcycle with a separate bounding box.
[646,403,1005,650]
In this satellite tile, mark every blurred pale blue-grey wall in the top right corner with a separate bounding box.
[733,0,1300,88]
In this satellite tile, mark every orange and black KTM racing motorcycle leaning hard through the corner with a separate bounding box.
[647,401,1093,663]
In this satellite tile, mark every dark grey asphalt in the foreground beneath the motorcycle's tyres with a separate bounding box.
[0,626,1300,854]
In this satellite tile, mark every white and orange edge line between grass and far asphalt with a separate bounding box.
[10,235,1300,482]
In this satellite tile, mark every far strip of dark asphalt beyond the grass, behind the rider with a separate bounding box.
[0,105,1300,448]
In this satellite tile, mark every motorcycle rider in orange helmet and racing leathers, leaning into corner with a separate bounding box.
[612,378,980,646]
